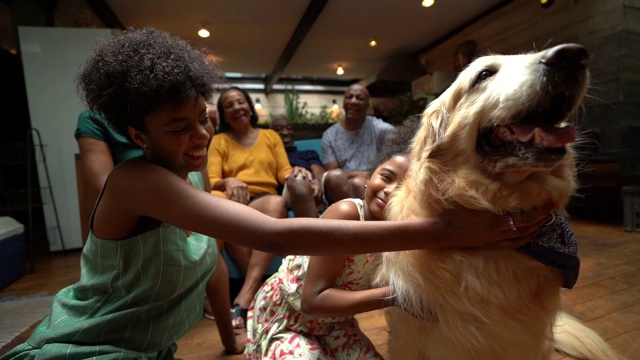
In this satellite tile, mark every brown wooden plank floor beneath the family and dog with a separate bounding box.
[0,220,640,360]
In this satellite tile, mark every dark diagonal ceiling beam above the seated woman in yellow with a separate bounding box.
[264,0,329,94]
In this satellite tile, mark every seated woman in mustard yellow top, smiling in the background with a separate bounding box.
[207,87,312,328]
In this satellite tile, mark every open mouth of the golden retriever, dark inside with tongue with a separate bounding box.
[477,92,576,162]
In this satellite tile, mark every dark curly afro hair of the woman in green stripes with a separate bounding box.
[78,28,224,137]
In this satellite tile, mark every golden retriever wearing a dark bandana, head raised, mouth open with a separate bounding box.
[378,44,618,360]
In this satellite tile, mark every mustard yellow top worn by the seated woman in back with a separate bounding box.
[207,129,291,197]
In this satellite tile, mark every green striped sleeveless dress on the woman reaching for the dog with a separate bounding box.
[0,173,218,360]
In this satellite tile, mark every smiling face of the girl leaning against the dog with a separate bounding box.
[364,155,409,220]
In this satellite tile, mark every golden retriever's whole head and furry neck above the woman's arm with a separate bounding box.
[405,44,589,215]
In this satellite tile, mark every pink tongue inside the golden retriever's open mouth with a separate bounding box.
[509,123,576,147]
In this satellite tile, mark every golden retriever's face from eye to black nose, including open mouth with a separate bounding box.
[440,44,589,171]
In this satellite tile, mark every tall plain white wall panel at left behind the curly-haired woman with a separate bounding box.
[18,27,111,251]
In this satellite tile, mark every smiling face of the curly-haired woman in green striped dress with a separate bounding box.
[129,97,214,178]
